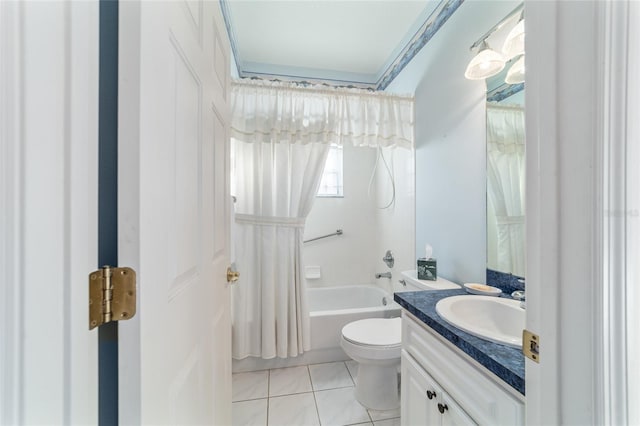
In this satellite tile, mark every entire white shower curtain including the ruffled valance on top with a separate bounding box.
[231,81,413,359]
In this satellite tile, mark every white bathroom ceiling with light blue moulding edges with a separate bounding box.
[222,0,462,89]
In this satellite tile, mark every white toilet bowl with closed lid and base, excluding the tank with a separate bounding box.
[340,318,401,410]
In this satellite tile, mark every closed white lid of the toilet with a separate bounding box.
[342,318,402,346]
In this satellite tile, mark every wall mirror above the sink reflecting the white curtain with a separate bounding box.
[486,68,526,277]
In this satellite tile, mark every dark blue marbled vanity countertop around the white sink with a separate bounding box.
[393,289,524,395]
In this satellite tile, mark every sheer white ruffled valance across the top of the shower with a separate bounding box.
[231,80,414,149]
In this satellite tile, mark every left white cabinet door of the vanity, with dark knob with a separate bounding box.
[400,350,442,426]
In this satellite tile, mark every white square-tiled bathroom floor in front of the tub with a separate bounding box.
[233,361,400,426]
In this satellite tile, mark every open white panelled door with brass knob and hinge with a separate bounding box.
[118,1,231,425]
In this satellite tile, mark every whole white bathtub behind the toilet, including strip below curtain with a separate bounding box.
[233,285,400,373]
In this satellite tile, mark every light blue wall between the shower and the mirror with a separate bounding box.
[387,1,518,283]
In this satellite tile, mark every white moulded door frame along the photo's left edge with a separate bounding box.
[0,1,99,425]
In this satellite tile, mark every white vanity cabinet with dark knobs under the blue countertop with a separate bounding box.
[400,311,524,426]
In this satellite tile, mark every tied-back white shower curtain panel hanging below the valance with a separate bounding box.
[232,140,329,359]
